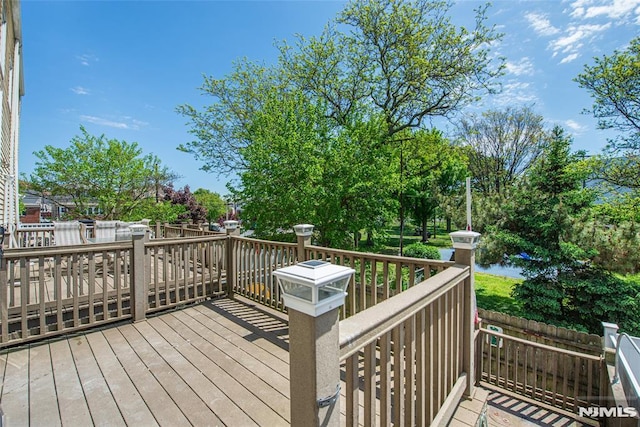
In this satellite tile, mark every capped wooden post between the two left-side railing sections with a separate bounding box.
[129,224,149,322]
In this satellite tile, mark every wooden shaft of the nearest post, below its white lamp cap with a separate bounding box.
[289,307,340,427]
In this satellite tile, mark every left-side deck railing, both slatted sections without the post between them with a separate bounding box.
[0,234,228,347]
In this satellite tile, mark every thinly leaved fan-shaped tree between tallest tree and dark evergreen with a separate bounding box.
[458,107,545,196]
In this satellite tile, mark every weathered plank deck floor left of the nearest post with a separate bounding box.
[0,299,289,426]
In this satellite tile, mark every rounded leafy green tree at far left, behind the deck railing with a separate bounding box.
[29,126,176,219]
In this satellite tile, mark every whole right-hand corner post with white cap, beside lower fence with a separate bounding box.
[449,231,480,397]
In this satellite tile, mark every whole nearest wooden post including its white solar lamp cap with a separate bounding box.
[273,260,355,427]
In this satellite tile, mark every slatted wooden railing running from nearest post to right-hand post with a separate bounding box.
[339,265,473,426]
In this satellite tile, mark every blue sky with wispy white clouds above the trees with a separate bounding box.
[19,0,640,195]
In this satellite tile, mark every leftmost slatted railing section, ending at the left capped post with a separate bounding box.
[0,242,132,346]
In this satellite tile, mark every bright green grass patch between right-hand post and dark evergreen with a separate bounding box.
[475,273,522,316]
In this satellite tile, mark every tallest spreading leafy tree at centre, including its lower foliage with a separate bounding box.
[178,0,502,246]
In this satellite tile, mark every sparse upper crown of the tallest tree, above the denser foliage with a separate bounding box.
[280,0,502,137]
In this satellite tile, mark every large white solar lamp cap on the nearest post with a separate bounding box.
[273,260,355,317]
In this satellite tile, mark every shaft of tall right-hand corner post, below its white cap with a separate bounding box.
[455,237,477,397]
